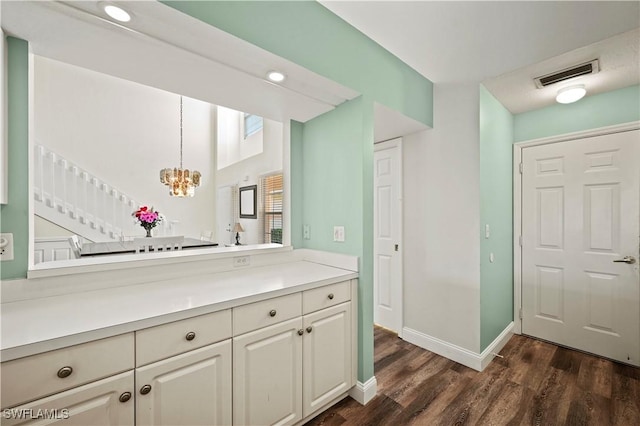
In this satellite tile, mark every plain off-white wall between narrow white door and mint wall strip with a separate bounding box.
[403,83,480,352]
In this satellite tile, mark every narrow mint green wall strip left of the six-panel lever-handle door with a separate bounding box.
[480,85,514,352]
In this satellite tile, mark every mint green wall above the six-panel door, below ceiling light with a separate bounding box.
[514,85,640,142]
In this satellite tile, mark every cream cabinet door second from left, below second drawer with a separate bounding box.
[136,339,231,426]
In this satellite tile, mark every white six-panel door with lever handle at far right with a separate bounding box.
[522,130,640,365]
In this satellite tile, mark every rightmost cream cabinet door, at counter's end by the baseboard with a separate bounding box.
[302,302,353,417]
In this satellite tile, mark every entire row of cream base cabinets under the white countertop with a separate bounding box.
[0,280,357,426]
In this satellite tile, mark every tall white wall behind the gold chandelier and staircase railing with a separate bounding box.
[34,56,216,237]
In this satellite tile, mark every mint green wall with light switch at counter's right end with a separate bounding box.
[301,97,373,381]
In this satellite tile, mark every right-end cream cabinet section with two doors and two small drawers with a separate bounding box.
[233,281,355,425]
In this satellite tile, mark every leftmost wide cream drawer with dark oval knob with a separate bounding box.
[0,333,134,408]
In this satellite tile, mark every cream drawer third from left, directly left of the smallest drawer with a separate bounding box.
[233,293,302,336]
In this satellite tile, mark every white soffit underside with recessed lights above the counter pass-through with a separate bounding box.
[0,1,358,122]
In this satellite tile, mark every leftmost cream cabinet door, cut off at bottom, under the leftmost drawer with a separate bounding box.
[2,371,134,426]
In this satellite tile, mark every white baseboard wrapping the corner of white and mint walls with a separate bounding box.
[402,322,513,371]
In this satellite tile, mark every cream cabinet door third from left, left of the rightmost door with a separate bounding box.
[233,317,302,425]
